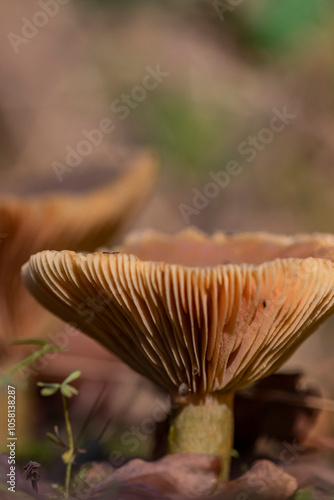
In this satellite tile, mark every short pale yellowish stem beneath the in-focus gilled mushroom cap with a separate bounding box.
[168,393,234,480]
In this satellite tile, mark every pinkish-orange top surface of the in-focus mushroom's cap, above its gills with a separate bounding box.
[115,228,334,266]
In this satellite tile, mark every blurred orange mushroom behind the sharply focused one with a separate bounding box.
[0,152,156,362]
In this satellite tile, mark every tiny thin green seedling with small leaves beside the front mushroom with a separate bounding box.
[37,371,85,500]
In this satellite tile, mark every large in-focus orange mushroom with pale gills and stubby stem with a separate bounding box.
[22,230,334,479]
